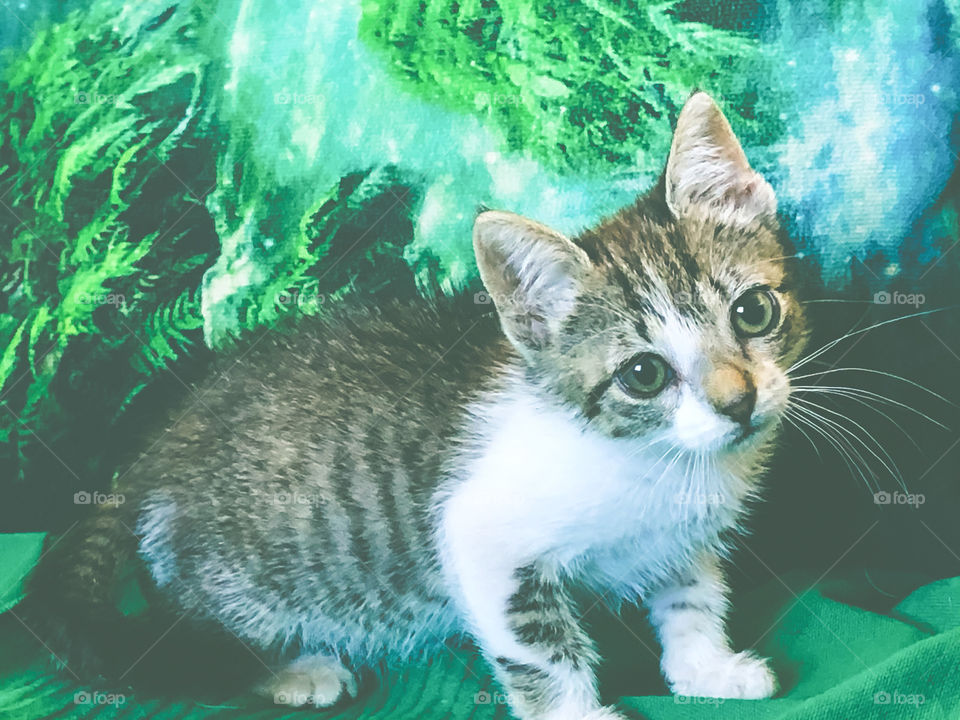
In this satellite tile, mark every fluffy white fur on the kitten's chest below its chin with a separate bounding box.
[442,386,748,593]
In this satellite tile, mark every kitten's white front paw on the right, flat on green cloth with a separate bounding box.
[663,651,777,700]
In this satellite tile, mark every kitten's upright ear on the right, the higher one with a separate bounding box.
[664,92,777,222]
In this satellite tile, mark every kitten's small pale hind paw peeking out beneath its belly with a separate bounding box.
[257,656,357,708]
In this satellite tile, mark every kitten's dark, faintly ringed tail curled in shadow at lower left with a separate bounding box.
[16,507,265,698]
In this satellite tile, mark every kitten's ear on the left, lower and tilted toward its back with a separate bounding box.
[473,211,590,357]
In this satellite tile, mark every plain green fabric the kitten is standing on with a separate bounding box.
[0,534,960,720]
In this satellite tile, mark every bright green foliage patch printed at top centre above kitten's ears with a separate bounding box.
[360,0,780,172]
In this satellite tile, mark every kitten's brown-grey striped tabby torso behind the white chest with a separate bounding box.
[121,298,508,656]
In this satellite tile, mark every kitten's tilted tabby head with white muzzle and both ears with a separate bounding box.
[474,93,806,452]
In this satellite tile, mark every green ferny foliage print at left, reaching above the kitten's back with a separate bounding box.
[0,0,418,496]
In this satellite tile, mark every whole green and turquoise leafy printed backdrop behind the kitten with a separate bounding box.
[0,0,957,500]
